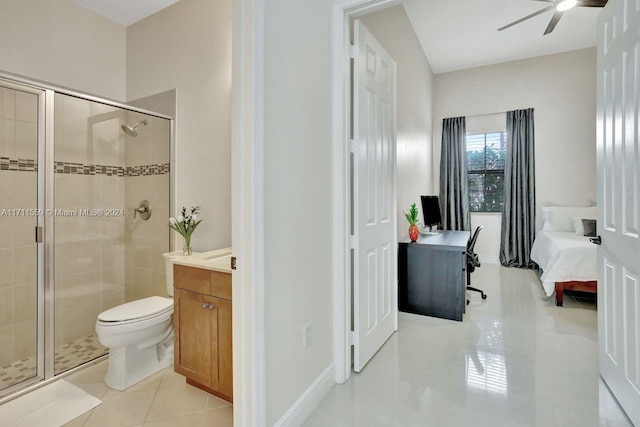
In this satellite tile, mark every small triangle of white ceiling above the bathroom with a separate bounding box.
[73,0,180,27]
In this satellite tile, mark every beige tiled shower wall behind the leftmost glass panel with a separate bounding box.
[0,88,37,366]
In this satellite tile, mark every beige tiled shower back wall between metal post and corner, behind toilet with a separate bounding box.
[55,94,125,346]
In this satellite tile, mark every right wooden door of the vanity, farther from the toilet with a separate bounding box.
[211,297,233,397]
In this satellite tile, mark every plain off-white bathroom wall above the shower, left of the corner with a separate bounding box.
[0,0,126,101]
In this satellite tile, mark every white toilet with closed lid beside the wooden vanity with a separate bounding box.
[96,251,182,390]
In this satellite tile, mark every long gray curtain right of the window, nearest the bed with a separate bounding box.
[500,108,536,268]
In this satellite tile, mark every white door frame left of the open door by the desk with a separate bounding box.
[331,0,403,384]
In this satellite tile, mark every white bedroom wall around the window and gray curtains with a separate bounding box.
[433,48,596,261]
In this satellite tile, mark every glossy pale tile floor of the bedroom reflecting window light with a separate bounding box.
[305,264,630,427]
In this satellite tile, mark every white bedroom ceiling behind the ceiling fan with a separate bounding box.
[404,0,602,74]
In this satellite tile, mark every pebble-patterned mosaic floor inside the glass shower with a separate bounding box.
[0,334,109,390]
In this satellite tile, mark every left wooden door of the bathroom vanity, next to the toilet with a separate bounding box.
[173,289,217,387]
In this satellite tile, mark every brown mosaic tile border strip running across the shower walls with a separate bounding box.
[0,157,171,178]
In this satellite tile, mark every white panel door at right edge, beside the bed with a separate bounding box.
[597,0,640,426]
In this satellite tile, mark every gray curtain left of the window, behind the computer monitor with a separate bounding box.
[440,117,471,230]
